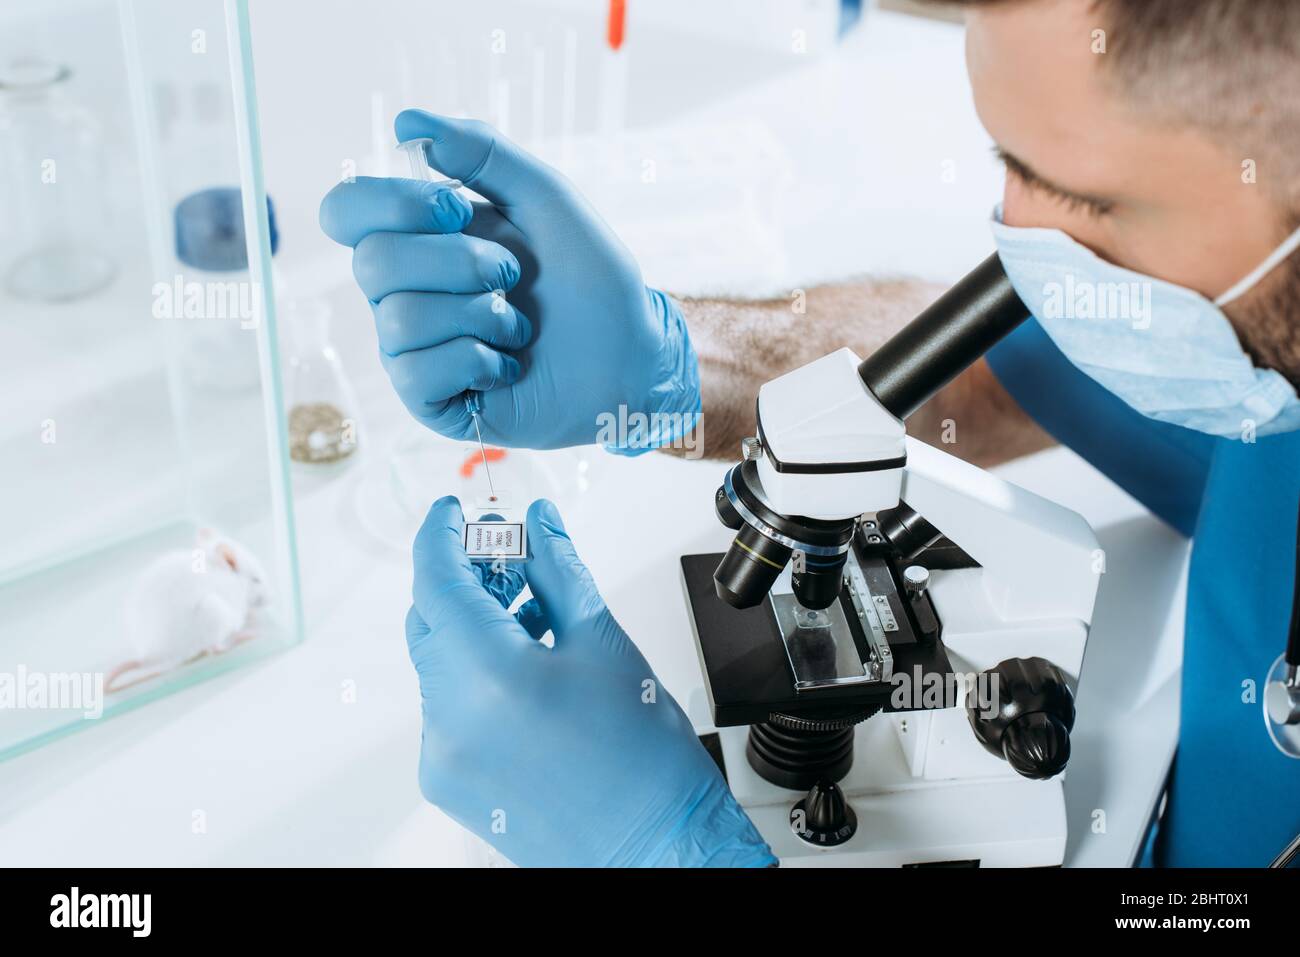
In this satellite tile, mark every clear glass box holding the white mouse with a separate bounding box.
[0,0,302,758]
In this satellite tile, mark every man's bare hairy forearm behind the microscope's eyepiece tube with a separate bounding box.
[681,280,1052,465]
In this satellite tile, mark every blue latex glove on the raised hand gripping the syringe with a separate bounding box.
[320,109,699,452]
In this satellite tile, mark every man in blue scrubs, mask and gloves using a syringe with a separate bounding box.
[321,0,1300,866]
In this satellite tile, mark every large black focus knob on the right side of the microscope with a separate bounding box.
[966,658,1074,780]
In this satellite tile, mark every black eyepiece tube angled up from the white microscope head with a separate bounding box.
[858,254,1030,419]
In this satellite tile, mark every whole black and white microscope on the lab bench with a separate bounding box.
[681,255,1102,867]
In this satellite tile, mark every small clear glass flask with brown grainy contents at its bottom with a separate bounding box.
[280,298,359,465]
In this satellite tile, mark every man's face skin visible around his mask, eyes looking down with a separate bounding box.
[966,0,1300,380]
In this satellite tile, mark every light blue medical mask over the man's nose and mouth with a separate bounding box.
[993,207,1300,438]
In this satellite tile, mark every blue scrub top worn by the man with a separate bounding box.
[988,320,1300,867]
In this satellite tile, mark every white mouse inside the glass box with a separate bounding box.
[104,528,269,692]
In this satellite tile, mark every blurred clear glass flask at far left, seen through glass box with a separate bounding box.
[0,59,116,302]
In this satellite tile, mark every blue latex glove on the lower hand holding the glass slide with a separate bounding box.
[407,497,775,867]
